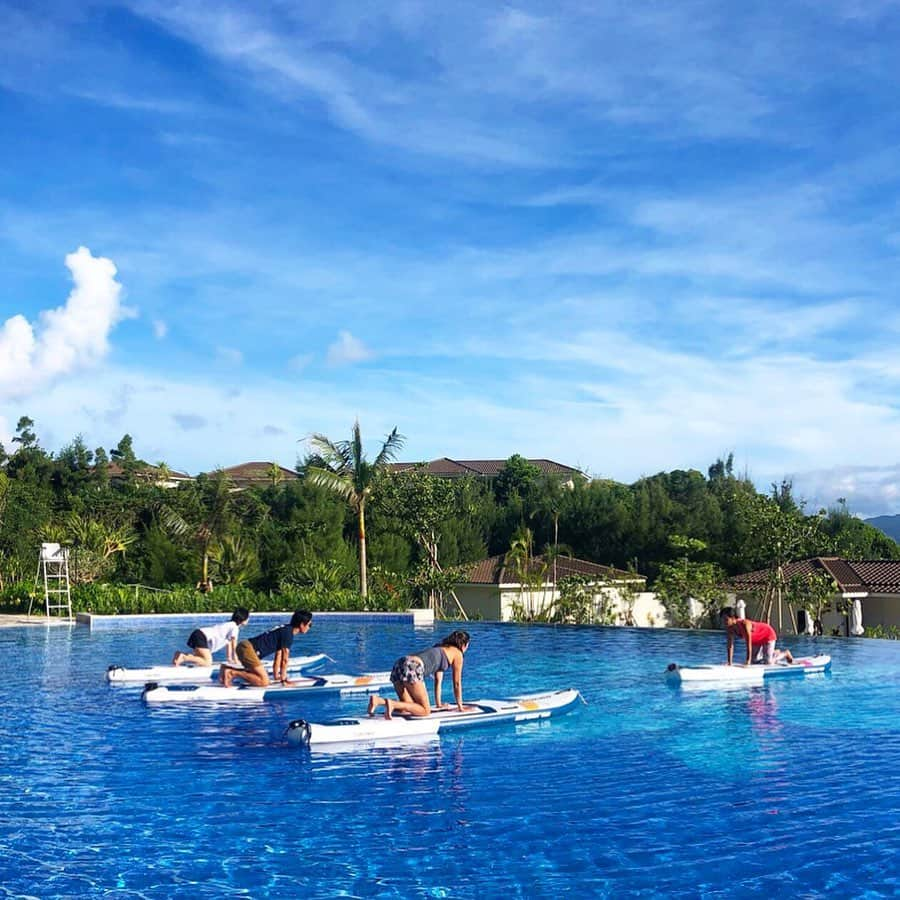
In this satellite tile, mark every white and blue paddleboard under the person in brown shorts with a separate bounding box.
[141,672,391,704]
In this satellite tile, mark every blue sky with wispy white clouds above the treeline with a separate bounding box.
[0,0,900,515]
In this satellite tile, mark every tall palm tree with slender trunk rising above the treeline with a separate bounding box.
[306,420,404,597]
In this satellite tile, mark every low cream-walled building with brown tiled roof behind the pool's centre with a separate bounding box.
[455,556,668,627]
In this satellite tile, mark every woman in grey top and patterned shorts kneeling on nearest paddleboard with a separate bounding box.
[369,631,469,719]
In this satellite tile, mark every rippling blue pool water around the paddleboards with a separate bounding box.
[0,619,900,898]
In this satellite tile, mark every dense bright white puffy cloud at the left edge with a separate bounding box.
[0,247,131,399]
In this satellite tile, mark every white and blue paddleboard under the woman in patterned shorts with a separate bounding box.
[287,689,584,748]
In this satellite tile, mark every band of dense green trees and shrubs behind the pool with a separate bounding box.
[0,416,900,621]
